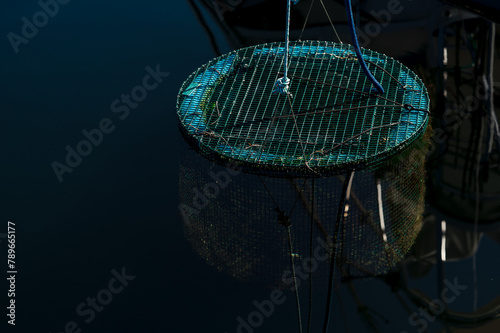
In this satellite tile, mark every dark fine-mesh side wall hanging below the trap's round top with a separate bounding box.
[179,126,429,288]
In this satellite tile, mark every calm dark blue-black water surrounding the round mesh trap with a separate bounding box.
[0,0,500,333]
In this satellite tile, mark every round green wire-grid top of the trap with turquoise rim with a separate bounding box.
[177,41,429,177]
